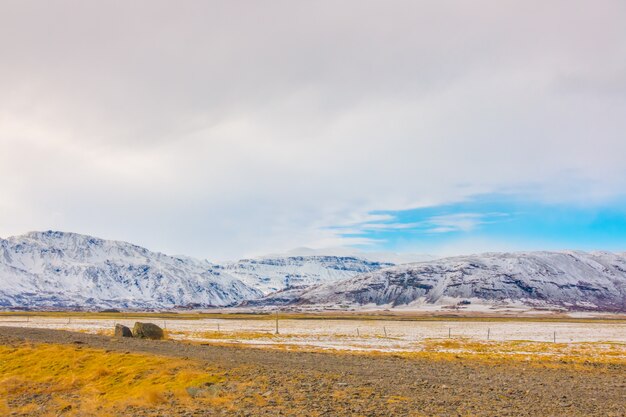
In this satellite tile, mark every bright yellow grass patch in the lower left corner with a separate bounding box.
[0,345,223,416]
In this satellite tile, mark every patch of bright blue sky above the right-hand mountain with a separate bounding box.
[334,194,626,252]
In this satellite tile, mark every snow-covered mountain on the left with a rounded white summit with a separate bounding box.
[0,231,261,309]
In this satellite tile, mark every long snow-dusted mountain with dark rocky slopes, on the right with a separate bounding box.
[249,252,626,312]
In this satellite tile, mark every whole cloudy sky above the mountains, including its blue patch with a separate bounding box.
[0,0,626,260]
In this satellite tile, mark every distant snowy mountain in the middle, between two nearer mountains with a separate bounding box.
[224,255,393,294]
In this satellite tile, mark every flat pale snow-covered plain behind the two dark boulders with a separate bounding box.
[0,316,626,352]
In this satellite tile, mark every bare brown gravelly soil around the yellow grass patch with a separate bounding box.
[0,327,626,417]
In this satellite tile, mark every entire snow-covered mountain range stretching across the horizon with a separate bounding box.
[0,231,626,312]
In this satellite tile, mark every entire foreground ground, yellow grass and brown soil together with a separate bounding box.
[0,327,626,417]
